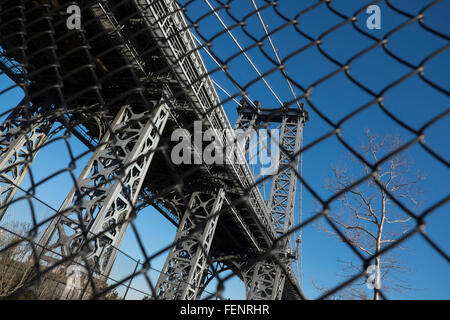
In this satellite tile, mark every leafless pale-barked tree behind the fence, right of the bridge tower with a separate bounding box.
[315,129,426,300]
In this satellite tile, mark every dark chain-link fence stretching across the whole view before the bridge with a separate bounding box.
[0,0,450,299]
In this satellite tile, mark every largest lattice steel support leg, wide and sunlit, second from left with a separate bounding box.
[40,101,169,276]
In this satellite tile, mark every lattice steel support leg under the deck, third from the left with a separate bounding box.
[156,189,225,300]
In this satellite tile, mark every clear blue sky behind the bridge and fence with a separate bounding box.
[0,0,450,299]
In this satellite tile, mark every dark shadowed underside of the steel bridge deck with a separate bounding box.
[0,0,300,299]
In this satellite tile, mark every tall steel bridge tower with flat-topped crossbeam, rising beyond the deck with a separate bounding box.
[235,100,308,300]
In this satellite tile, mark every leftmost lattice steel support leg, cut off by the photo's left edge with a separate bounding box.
[0,98,55,220]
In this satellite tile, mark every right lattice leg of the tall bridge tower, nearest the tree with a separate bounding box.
[247,108,305,300]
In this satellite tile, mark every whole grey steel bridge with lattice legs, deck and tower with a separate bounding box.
[0,0,307,300]
